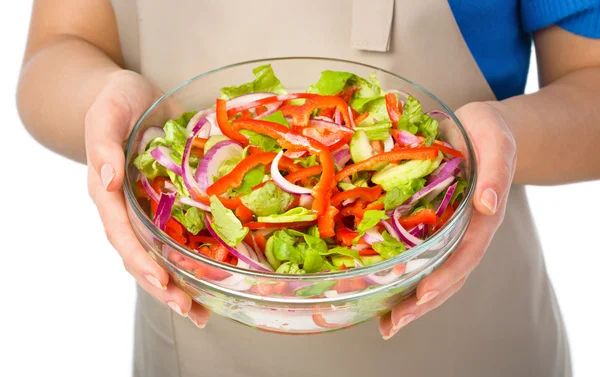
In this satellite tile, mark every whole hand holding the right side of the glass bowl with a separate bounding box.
[379,102,517,339]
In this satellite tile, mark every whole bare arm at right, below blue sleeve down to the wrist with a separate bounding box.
[498,26,600,185]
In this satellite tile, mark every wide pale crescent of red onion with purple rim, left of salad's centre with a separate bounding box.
[195,140,244,191]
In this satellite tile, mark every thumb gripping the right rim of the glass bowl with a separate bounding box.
[456,103,516,215]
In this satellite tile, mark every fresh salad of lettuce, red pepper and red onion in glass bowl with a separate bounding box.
[134,65,466,274]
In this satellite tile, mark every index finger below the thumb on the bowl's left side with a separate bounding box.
[88,169,169,290]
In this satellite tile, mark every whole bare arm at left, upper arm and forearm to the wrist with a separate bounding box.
[17,0,123,162]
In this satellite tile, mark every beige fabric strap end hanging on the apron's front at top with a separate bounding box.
[351,0,394,52]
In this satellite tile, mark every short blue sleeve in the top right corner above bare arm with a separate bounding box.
[521,0,600,38]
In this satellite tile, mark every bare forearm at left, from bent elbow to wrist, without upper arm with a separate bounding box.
[17,36,121,162]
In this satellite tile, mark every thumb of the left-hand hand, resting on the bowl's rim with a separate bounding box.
[85,72,154,191]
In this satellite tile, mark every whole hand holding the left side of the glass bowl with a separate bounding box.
[85,71,210,328]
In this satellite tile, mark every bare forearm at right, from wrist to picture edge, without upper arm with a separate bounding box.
[497,68,600,185]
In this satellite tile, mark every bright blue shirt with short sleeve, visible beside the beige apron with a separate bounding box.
[448,0,600,99]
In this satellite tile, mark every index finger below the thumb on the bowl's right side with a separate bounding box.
[416,206,506,304]
